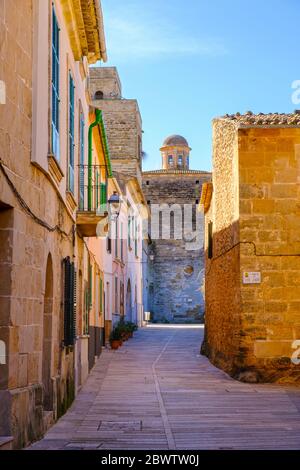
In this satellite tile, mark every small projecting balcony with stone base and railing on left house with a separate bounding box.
[76,165,107,237]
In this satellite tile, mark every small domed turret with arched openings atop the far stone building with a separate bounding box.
[160,135,191,170]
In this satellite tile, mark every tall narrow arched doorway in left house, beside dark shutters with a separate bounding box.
[42,253,53,410]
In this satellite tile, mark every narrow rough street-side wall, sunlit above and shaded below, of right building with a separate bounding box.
[203,122,240,370]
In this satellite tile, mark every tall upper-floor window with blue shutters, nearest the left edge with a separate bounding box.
[51,9,60,160]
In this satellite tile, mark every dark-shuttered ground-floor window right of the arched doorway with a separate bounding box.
[63,257,76,346]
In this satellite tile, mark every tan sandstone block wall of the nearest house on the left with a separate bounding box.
[0,0,81,448]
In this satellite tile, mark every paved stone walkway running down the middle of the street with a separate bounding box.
[31,328,300,450]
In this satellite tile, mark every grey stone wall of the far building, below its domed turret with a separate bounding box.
[143,170,210,323]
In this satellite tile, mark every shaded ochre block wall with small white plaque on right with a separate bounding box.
[239,127,300,381]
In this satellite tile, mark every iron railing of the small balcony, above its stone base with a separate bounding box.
[78,165,107,214]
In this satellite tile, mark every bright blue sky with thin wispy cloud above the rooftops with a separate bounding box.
[102,0,300,170]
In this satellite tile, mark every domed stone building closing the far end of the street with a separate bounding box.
[143,135,210,323]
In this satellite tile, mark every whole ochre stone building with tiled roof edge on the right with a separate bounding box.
[201,112,300,382]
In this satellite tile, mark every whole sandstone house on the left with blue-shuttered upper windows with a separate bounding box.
[0,0,115,448]
